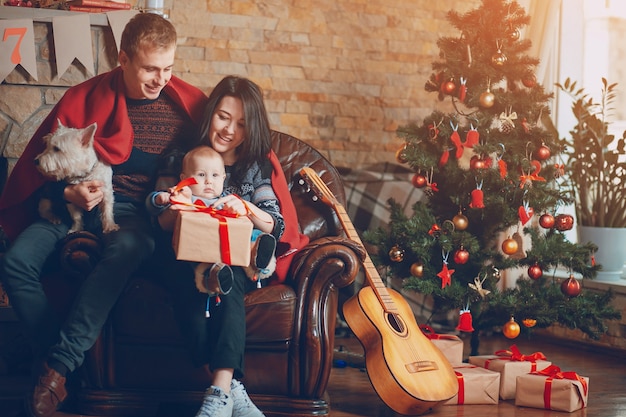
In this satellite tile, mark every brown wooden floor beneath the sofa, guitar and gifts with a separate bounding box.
[0,328,626,417]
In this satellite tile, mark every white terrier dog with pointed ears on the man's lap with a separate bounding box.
[35,120,119,234]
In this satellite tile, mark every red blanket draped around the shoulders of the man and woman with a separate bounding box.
[0,67,308,282]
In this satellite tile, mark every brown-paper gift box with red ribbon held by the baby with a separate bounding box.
[172,211,252,266]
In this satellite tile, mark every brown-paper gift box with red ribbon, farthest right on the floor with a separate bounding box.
[515,365,589,413]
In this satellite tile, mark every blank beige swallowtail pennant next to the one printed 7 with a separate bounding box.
[52,13,96,78]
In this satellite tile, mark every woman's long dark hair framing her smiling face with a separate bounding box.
[198,75,271,184]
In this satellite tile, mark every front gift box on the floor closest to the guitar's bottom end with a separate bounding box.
[444,365,500,405]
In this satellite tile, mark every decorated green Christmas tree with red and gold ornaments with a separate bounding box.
[364,0,620,354]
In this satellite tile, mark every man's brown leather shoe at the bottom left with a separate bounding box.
[27,364,67,417]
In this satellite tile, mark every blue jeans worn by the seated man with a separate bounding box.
[0,203,155,371]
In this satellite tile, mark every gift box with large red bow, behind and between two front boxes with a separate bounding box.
[469,345,552,400]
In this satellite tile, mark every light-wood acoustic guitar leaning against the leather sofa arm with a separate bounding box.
[300,167,459,415]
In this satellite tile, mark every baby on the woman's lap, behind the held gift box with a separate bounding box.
[146,145,276,295]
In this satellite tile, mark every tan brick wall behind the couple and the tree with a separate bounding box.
[0,0,480,172]
